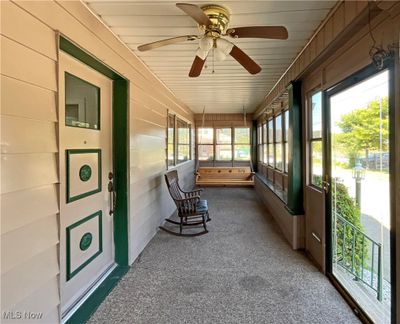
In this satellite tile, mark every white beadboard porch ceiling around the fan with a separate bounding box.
[84,0,336,113]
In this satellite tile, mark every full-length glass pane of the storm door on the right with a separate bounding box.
[326,69,391,324]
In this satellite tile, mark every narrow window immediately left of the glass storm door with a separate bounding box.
[309,91,322,187]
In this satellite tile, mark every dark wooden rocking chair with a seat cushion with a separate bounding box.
[160,170,211,236]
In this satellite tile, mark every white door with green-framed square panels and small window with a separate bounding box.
[59,52,114,317]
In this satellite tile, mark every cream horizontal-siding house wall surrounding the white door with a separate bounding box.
[1,1,194,323]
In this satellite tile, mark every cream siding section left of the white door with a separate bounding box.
[0,1,60,323]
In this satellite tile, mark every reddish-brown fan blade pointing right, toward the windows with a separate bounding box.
[226,26,288,39]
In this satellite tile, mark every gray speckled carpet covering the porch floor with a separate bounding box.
[89,188,359,324]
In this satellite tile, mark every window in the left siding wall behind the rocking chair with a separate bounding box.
[167,114,191,166]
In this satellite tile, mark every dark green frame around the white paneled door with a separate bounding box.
[57,33,129,323]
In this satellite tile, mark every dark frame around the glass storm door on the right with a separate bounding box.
[322,58,397,323]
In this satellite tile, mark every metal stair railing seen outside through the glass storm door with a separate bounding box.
[333,214,383,301]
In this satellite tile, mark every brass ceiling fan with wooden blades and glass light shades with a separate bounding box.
[138,3,288,77]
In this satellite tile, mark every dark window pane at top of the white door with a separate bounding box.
[65,73,100,129]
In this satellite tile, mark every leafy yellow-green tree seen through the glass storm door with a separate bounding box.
[336,97,389,165]
